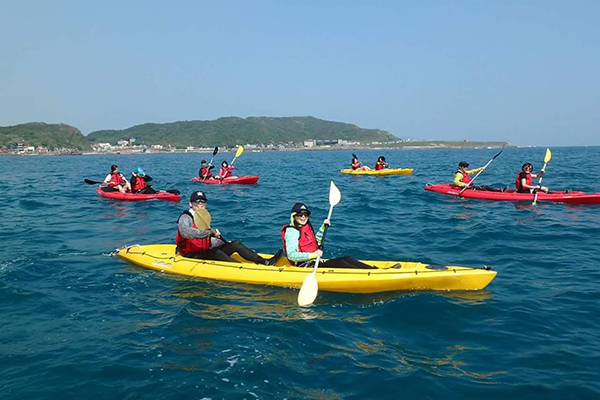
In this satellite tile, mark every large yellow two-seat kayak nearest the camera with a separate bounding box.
[118,244,496,293]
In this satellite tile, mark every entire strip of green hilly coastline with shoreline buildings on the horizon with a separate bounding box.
[0,117,507,151]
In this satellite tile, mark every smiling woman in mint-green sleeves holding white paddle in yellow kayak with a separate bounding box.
[281,203,376,269]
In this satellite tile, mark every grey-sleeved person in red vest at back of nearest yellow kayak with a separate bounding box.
[175,192,281,265]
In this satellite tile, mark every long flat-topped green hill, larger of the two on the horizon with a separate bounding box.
[88,117,398,147]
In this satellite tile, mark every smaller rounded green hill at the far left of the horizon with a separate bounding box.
[0,122,91,150]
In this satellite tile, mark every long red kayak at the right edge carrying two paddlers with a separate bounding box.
[425,184,600,204]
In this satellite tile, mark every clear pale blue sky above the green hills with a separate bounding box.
[0,0,600,146]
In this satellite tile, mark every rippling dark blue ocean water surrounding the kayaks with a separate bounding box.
[0,147,600,399]
